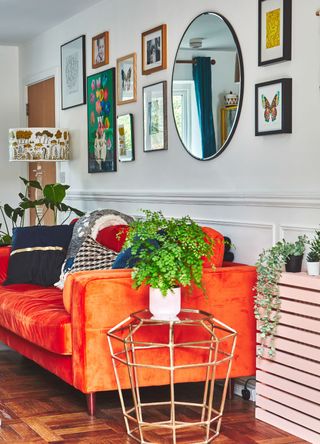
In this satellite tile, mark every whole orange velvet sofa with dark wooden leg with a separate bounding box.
[0,247,256,414]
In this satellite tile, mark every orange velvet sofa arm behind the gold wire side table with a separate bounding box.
[64,265,256,393]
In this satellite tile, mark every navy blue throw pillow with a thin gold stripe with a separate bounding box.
[3,225,73,287]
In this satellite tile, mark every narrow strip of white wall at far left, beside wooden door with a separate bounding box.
[0,46,26,216]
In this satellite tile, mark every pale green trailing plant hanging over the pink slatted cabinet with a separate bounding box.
[254,236,307,357]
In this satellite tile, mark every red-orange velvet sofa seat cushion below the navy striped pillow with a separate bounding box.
[0,284,72,354]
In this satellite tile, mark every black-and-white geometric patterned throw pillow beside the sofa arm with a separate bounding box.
[69,236,117,273]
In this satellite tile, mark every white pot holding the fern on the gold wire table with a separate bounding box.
[149,287,181,321]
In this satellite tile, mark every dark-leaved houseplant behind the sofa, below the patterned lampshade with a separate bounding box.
[0,177,84,245]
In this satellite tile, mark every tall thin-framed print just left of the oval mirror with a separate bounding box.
[143,82,168,152]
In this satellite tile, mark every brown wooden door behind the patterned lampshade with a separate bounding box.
[28,78,56,225]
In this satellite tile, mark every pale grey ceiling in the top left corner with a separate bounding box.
[0,0,101,45]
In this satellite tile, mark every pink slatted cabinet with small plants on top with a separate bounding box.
[256,273,320,444]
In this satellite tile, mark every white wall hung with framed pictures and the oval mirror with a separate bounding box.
[20,0,320,263]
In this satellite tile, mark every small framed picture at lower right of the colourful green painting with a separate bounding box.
[117,114,134,162]
